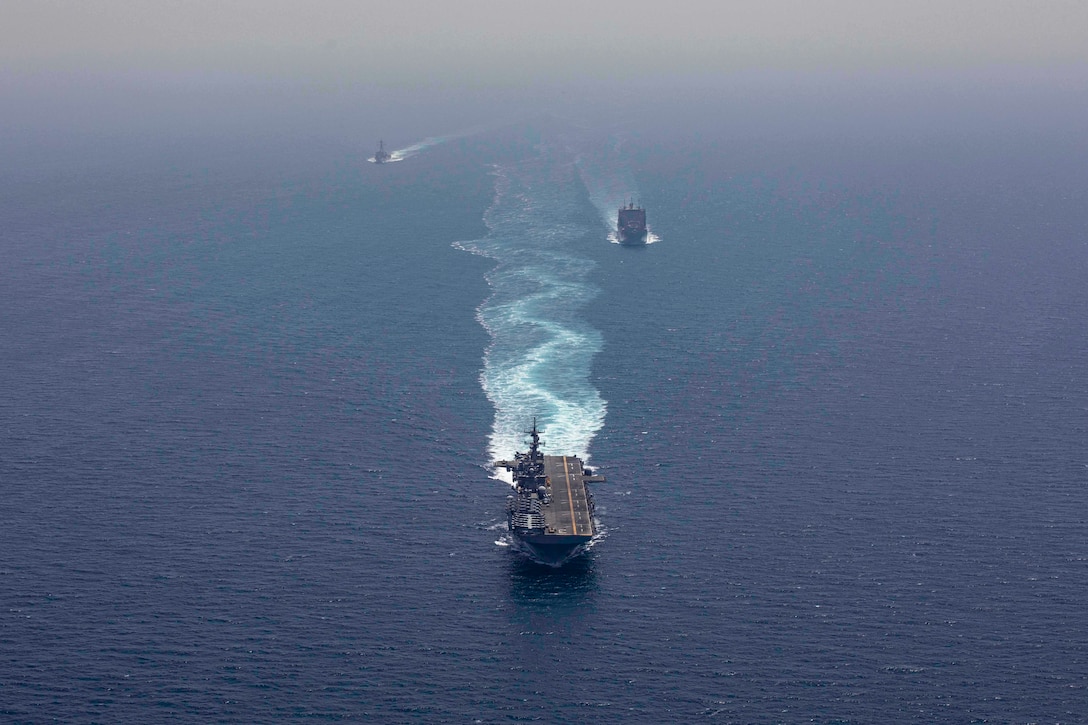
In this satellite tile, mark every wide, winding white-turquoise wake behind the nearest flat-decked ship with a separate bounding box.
[455,152,606,460]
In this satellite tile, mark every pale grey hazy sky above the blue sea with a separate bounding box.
[6,0,1088,84]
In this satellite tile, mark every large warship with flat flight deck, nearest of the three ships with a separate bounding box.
[495,420,605,566]
